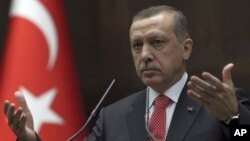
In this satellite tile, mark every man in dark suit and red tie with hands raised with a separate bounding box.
[4,6,250,141]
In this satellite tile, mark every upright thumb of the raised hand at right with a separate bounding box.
[222,63,234,86]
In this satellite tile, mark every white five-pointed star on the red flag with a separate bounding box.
[19,86,64,133]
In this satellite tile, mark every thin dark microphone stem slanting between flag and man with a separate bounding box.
[67,79,115,141]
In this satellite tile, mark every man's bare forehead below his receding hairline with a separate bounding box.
[130,12,174,38]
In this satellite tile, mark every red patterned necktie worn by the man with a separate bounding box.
[149,94,169,141]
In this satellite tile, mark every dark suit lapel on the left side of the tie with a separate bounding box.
[127,90,147,141]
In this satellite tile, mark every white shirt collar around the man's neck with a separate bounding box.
[148,72,188,107]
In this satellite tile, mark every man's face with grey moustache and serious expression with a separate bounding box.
[130,12,192,92]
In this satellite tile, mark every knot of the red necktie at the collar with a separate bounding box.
[154,94,170,109]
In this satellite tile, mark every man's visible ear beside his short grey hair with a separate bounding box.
[183,38,193,60]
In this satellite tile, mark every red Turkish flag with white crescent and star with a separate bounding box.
[0,0,85,141]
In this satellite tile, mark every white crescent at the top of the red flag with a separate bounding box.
[10,0,58,70]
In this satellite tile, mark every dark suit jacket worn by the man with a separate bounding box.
[85,86,250,141]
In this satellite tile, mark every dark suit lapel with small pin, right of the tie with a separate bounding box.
[167,85,201,141]
